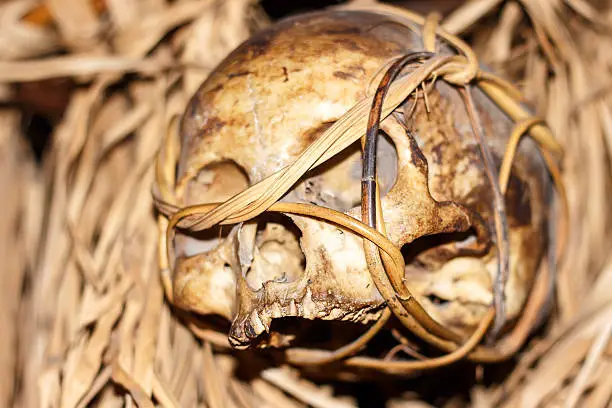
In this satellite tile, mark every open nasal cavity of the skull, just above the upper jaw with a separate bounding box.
[240,214,306,290]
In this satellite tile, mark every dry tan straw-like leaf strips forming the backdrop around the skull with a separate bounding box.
[0,0,612,407]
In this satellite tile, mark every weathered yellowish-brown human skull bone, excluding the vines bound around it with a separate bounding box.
[173,10,549,348]
